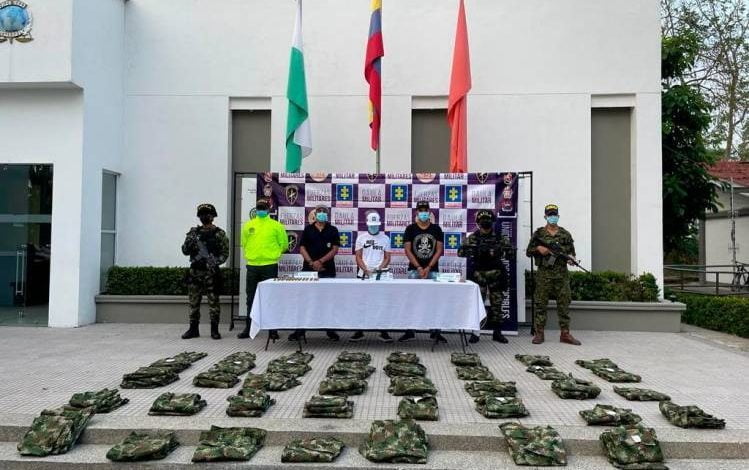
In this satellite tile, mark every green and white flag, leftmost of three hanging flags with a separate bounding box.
[286,0,312,173]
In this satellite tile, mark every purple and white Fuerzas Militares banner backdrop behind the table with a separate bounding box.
[250,173,518,332]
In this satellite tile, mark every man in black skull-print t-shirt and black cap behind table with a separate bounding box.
[398,201,447,343]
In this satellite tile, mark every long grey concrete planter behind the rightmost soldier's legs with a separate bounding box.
[525,301,687,333]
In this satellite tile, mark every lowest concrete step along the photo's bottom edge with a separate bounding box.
[0,442,749,470]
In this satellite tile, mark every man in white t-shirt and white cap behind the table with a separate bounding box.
[350,212,393,343]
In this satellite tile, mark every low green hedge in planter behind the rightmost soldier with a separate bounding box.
[525,271,659,302]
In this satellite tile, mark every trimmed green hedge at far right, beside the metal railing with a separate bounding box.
[669,293,749,338]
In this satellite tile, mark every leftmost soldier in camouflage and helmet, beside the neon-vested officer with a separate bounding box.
[182,204,229,339]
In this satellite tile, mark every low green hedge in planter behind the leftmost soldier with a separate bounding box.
[103,266,239,295]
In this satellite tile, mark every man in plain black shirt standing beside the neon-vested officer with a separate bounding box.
[289,207,341,341]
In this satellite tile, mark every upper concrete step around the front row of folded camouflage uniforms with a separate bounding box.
[0,415,749,459]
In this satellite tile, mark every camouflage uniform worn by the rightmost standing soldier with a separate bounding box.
[526,227,576,330]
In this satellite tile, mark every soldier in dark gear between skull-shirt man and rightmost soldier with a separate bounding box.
[458,210,515,343]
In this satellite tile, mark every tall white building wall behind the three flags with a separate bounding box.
[118,0,662,277]
